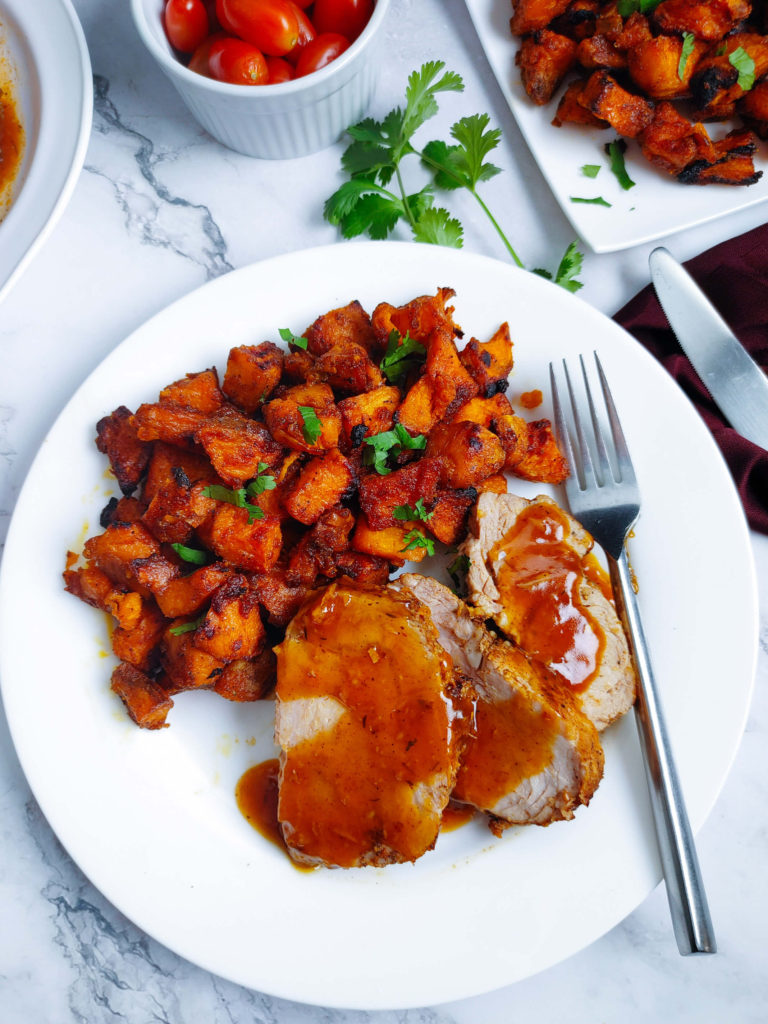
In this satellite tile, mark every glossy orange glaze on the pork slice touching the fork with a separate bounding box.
[489,505,605,689]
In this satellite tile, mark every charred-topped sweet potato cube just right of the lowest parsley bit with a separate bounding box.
[193,575,266,662]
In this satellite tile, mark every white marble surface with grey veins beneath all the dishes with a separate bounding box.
[0,0,768,1024]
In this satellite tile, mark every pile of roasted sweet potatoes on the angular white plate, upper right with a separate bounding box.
[511,0,768,185]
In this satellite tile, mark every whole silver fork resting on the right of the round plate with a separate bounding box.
[549,353,717,955]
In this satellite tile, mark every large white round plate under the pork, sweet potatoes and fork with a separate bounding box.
[0,242,757,1009]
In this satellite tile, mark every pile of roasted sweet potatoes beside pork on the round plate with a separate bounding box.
[63,289,567,728]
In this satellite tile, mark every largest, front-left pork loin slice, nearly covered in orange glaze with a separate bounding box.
[275,583,472,867]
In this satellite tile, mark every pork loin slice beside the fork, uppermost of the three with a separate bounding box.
[461,494,636,730]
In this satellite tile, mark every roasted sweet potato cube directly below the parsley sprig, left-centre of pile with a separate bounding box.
[198,502,283,572]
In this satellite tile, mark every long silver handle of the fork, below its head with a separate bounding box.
[608,548,717,956]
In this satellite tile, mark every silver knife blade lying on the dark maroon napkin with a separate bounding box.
[648,246,768,449]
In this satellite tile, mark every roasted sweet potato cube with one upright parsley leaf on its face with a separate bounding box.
[264,383,341,453]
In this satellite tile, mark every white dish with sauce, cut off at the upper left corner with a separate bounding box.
[0,0,93,301]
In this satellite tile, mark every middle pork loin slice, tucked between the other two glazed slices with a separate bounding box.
[396,573,603,835]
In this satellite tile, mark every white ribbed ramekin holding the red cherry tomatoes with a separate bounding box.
[131,0,389,160]
